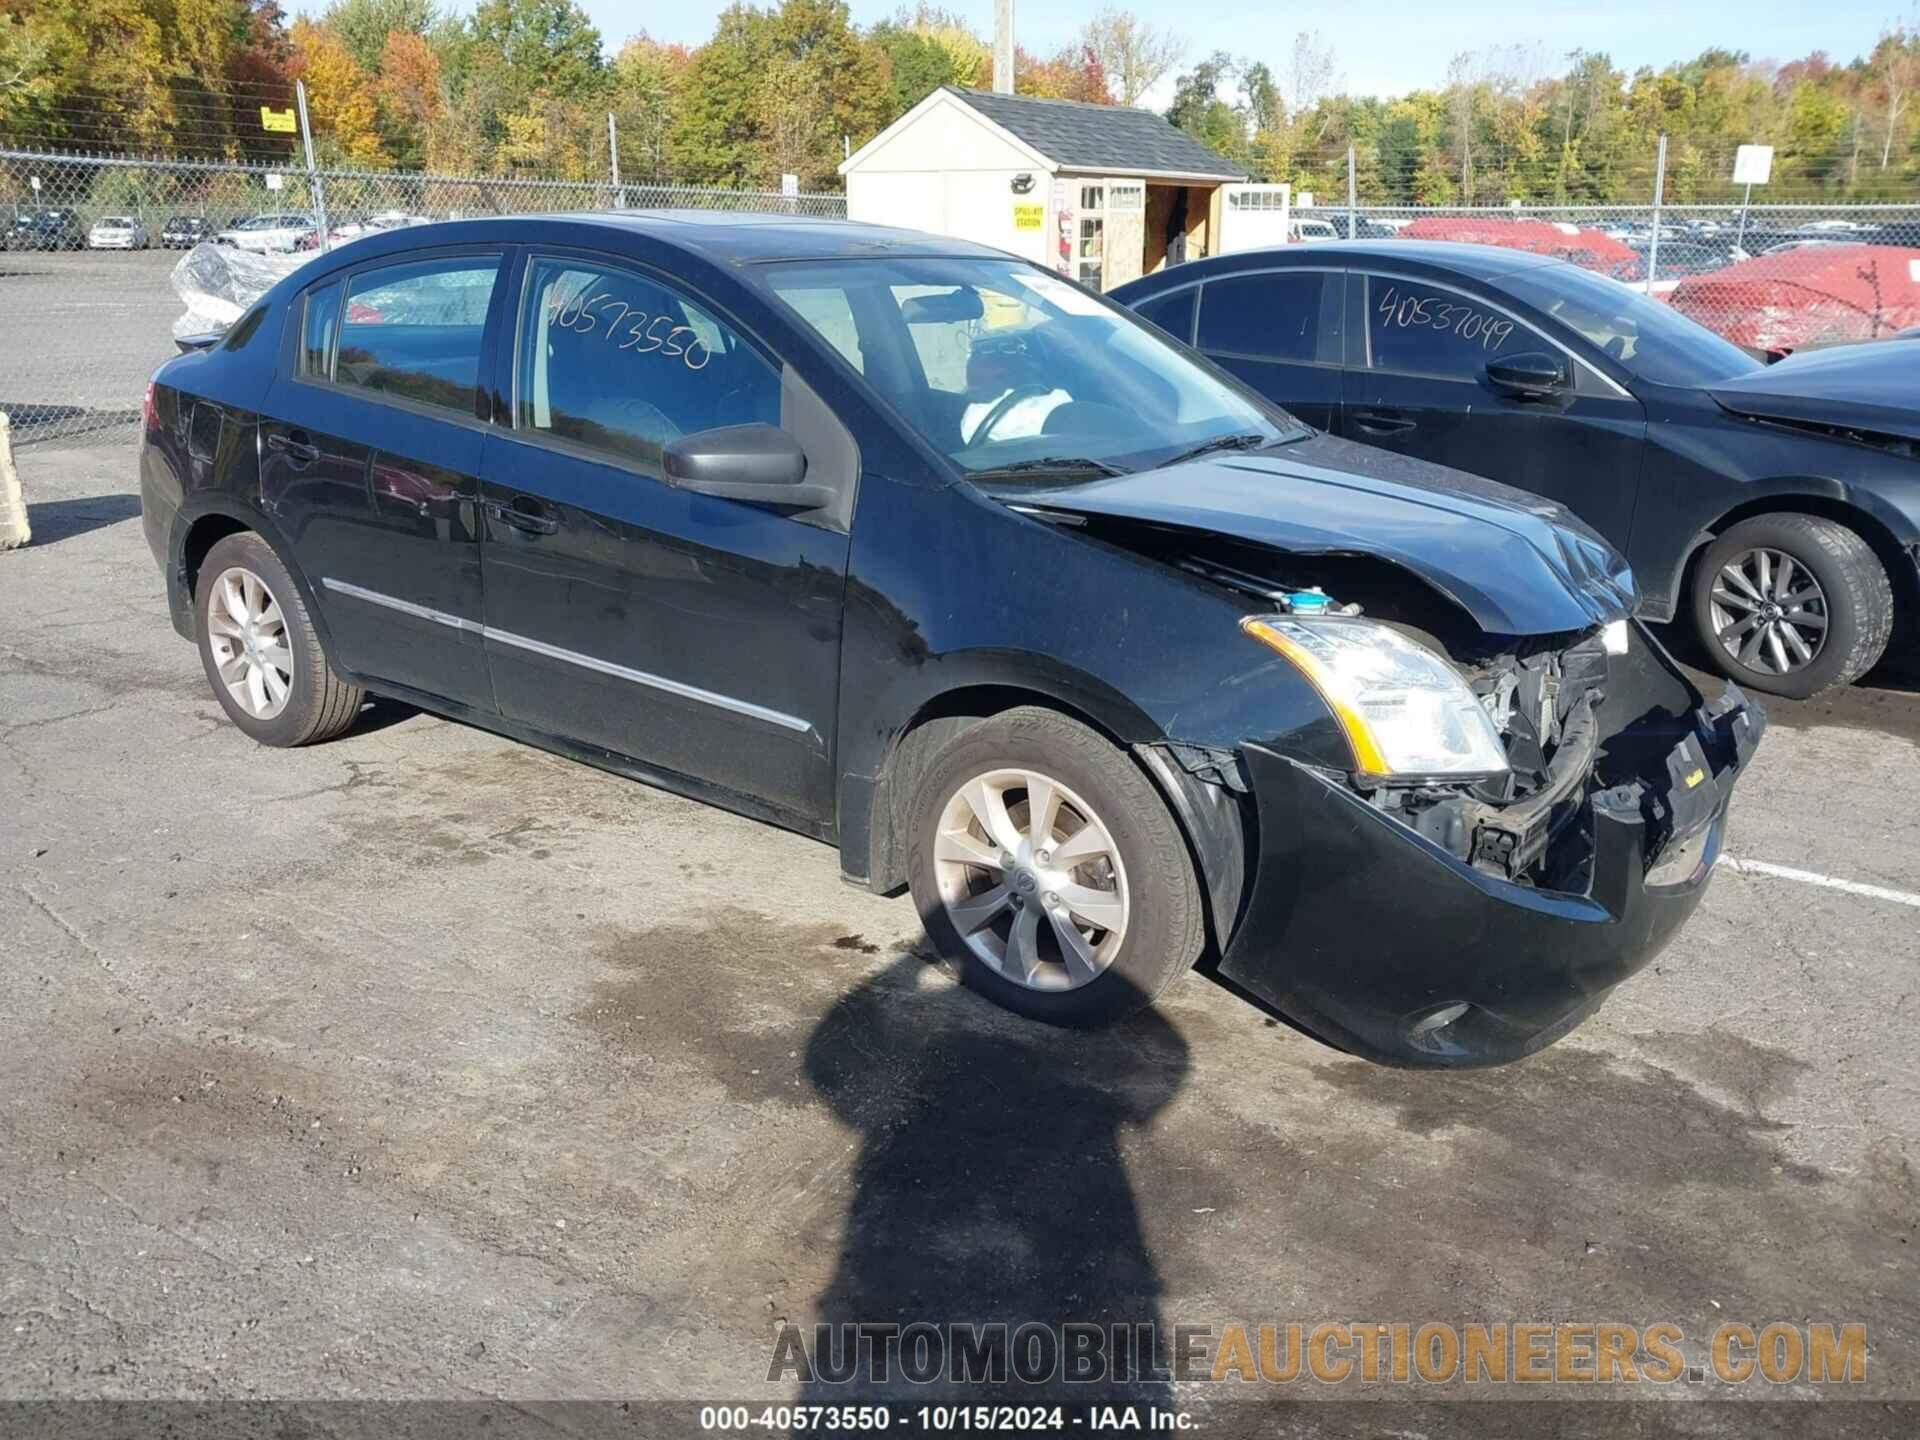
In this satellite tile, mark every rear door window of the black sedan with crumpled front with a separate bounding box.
[334,255,499,415]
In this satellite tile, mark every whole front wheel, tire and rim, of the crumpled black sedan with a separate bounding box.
[908,707,1206,1025]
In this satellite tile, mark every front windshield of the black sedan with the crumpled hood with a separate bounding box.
[762,259,1309,480]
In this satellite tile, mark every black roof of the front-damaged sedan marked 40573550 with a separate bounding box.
[305,209,1008,265]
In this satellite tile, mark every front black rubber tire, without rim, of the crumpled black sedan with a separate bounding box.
[906,707,1206,1025]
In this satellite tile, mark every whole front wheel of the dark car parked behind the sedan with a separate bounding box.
[1693,515,1893,699]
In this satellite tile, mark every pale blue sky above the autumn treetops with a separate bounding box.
[292,0,1916,94]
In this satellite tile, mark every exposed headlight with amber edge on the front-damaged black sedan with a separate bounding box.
[1240,614,1507,780]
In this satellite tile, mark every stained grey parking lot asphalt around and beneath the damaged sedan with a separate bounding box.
[0,443,1920,1434]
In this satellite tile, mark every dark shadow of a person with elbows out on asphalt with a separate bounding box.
[803,952,1188,1405]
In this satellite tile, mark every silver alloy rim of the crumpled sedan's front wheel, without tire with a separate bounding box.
[933,770,1131,991]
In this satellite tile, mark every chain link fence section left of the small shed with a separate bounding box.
[0,150,847,445]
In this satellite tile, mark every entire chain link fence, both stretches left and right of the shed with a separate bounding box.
[0,150,1920,444]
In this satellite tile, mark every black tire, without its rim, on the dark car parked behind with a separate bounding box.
[1693,515,1893,701]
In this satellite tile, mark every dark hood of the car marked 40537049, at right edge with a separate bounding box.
[1707,340,1920,440]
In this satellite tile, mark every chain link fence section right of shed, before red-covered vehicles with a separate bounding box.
[1292,205,1920,357]
